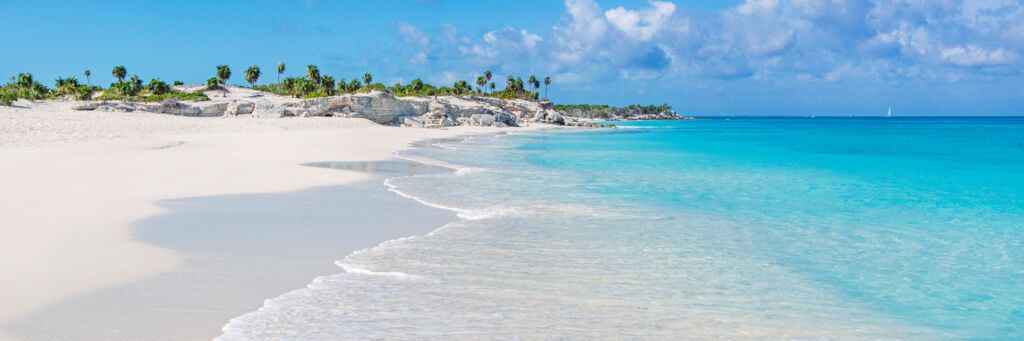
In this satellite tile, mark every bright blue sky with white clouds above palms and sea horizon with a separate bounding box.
[0,0,1024,116]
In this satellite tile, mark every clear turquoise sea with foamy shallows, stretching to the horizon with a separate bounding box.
[223,118,1024,340]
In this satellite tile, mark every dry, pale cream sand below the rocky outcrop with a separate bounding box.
[0,96,557,337]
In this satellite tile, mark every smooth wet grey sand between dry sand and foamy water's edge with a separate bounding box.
[6,160,456,340]
